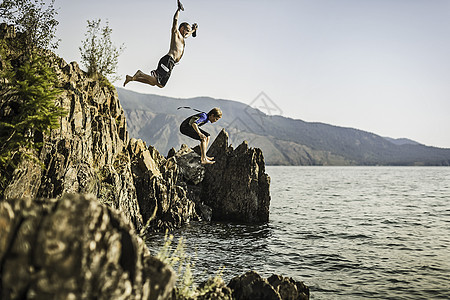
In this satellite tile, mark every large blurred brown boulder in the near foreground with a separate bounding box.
[0,195,175,299]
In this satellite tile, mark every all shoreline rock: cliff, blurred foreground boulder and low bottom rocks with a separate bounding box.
[0,24,309,299]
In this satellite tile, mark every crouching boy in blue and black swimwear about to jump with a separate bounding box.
[180,107,222,164]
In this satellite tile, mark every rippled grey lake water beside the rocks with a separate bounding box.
[149,167,450,299]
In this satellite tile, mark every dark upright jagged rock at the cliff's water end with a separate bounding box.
[202,130,270,223]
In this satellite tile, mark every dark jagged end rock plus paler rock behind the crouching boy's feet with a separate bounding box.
[169,129,270,223]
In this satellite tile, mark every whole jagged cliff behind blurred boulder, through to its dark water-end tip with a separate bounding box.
[0,22,270,234]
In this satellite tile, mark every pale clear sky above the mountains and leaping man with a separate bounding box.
[55,0,450,148]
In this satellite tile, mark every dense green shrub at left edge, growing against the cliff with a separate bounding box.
[0,52,66,196]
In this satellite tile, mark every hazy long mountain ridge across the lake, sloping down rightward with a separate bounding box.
[117,88,450,166]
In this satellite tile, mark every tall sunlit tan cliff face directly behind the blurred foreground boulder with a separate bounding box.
[0,25,142,229]
